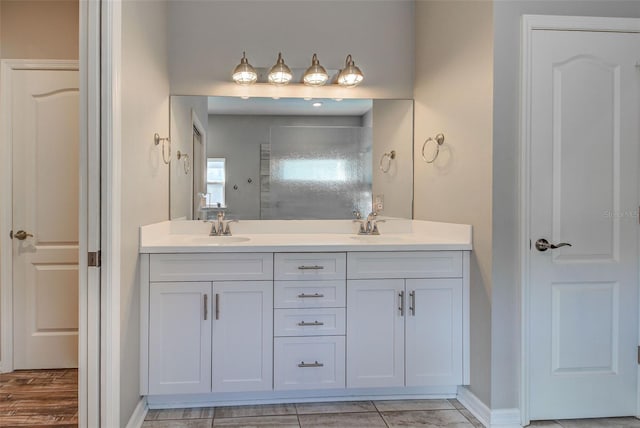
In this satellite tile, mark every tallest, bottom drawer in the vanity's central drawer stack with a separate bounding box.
[274,336,345,391]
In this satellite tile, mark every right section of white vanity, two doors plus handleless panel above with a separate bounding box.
[347,251,464,388]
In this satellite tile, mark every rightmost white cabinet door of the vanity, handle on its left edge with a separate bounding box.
[405,278,462,386]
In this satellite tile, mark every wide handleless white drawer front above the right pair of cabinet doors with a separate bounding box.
[347,251,462,279]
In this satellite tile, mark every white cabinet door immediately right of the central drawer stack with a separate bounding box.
[347,279,404,388]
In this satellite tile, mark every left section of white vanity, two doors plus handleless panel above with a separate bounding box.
[140,253,273,395]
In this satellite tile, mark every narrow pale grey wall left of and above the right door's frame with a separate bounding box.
[491,0,640,409]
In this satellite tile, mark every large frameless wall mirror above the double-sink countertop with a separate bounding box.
[169,96,413,220]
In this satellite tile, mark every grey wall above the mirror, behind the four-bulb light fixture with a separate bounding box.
[169,0,414,98]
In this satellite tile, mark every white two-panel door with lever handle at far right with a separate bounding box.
[528,30,640,419]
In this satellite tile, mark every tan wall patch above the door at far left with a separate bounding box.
[0,0,79,59]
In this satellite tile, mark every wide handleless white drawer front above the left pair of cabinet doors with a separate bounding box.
[149,253,273,281]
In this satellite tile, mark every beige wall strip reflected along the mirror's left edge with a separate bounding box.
[169,96,209,219]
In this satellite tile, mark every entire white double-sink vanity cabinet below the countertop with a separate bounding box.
[140,244,469,408]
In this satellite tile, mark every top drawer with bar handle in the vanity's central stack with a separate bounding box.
[275,253,346,280]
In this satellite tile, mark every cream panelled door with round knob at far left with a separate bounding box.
[11,70,80,369]
